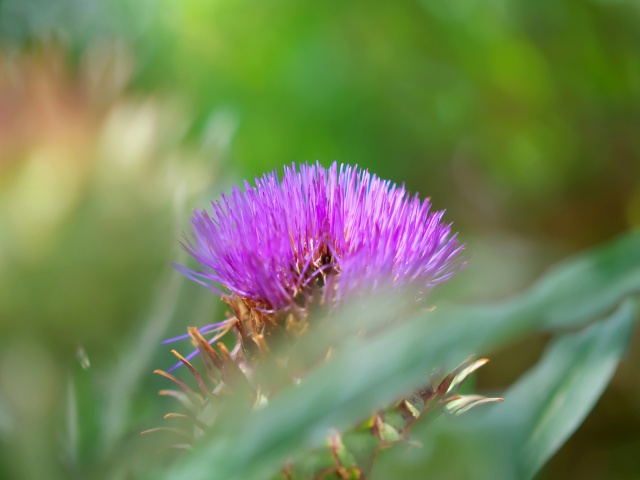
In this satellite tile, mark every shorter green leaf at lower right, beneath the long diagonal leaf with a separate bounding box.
[376,300,636,479]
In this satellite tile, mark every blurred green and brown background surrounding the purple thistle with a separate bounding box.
[0,0,640,479]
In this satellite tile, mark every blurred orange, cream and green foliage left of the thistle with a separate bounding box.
[0,47,225,478]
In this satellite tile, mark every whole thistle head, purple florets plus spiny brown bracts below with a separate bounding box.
[147,163,500,478]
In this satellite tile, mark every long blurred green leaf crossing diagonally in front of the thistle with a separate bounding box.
[149,232,640,480]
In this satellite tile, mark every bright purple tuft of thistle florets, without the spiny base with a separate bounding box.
[177,163,464,316]
